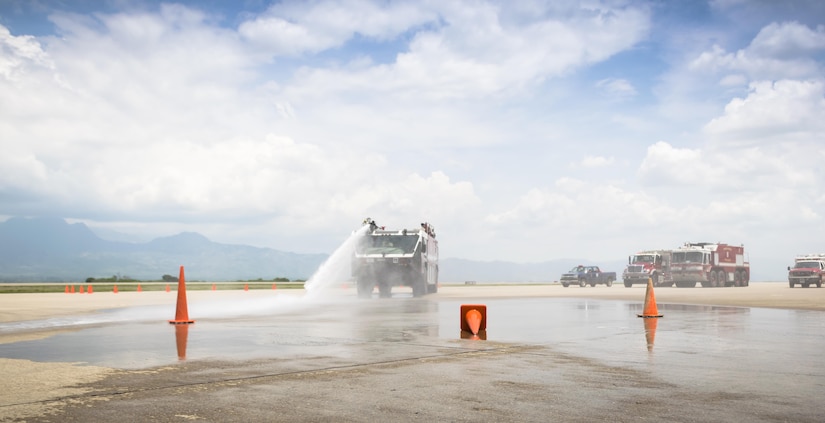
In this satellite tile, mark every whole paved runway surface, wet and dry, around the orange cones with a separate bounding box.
[0,284,825,422]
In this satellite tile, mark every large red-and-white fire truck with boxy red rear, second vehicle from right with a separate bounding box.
[670,242,750,288]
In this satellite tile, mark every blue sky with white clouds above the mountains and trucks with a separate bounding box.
[0,0,825,278]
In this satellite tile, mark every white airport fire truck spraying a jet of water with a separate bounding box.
[352,218,438,298]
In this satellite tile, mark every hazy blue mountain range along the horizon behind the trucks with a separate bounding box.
[0,217,624,283]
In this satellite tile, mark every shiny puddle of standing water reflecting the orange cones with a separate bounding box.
[0,297,825,371]
